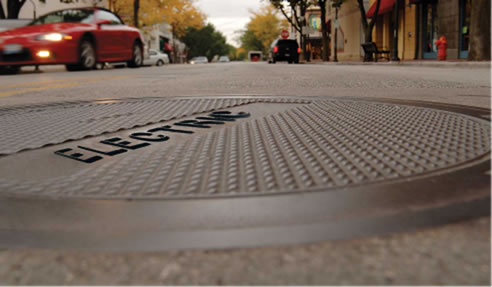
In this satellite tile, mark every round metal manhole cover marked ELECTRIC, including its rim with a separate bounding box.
[0,96,490,250]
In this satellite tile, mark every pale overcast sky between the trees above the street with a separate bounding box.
[196,0,263,46]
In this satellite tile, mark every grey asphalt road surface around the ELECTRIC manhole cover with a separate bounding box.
[0,63,491,285]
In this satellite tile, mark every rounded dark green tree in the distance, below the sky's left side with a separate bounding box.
[181,24,230,61]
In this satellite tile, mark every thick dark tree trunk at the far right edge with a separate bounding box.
[468,0,490,61]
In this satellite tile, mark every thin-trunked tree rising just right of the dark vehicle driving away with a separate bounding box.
[269,0,314,59]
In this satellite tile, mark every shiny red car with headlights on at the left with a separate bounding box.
[0,7,144,72]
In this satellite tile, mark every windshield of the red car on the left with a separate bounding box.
[29,9,94,25]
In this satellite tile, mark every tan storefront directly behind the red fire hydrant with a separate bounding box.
[366,0,473,60]
